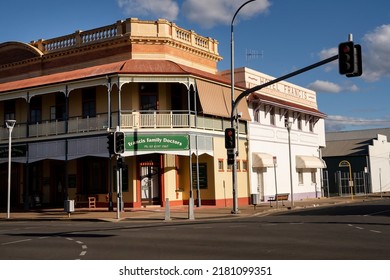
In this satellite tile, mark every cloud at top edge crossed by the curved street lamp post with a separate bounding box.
[183,0,271,28]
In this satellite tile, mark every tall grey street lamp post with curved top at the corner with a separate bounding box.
[230,0,256,214]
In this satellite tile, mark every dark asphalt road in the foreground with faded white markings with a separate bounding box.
[0,199,390,260]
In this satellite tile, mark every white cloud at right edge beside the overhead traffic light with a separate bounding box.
[362,24,390,81]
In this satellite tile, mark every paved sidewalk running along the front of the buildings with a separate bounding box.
[0,193,390,222]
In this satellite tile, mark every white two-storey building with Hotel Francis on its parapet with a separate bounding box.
[221,68,326,202]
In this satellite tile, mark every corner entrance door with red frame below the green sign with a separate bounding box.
[140,165,160,205]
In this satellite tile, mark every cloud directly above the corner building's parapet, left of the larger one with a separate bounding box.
[117,0,179,21]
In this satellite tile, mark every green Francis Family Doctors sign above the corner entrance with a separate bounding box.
[125,133,189,151]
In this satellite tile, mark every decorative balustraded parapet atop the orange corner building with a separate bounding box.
[31,18,219,56]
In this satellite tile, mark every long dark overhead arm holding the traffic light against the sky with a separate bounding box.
[230,54,339,121]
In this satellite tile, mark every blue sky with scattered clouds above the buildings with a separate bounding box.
[0,0,390,132]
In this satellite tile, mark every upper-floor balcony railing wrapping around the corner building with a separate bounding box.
[0,111,246,142]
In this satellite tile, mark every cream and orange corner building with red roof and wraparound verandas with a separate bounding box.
[0,18,251,209]
